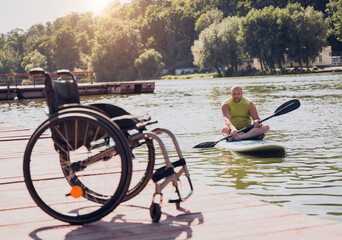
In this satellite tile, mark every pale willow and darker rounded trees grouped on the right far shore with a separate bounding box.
[192,4,329,75]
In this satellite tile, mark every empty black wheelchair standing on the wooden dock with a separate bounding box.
[23,68,193,224]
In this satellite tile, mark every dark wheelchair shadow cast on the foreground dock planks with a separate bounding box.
[29,205,204,240]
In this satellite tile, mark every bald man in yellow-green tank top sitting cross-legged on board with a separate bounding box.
[221,85,270,141]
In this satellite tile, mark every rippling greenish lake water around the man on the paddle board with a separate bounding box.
[0,75,342,221]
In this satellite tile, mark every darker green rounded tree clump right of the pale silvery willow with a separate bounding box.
[241,4,329,71]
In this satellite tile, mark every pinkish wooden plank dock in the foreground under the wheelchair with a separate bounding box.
[0,122,342,240]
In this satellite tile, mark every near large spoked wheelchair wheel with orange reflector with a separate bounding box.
[23,112,132,224]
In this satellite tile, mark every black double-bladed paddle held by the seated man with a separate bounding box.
[194,99,300,148]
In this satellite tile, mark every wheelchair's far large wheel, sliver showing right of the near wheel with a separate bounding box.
[123,133,155,201]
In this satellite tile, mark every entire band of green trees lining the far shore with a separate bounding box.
[0,0,342,81]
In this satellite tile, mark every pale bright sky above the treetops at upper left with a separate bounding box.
[0,0,131,33]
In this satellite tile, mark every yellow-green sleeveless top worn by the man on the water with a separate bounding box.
[227,97,252,130]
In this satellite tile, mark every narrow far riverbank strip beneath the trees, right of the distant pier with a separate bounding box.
[161,66,342,80]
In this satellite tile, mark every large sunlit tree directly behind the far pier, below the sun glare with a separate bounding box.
[92,19,142,81]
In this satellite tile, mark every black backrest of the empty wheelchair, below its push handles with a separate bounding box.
[45,70,80,114]
